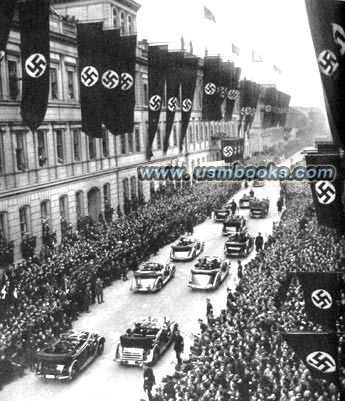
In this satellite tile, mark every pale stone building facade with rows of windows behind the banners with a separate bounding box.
[0,0,237,260]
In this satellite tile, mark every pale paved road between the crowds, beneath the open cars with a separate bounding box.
[0,151,304,401]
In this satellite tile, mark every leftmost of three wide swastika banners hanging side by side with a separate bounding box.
[77,22,105,138]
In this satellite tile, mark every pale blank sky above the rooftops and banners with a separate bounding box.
[137,0,324,109]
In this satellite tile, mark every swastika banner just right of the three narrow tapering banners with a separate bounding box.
[202,56,221,121]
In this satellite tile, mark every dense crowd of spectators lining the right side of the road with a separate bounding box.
[152,183,345,401]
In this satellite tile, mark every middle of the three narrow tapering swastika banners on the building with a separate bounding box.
[163,52,184,153]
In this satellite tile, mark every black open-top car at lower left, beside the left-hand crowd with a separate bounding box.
[35,331,105,380]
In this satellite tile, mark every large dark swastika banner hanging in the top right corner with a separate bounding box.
[305,0,345,147]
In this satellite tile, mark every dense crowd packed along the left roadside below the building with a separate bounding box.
[0,183,239,384]
